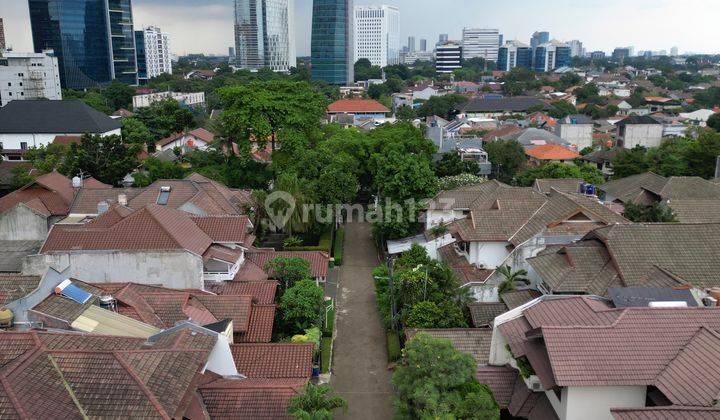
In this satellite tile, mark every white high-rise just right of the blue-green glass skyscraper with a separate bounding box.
[355,5,400,67]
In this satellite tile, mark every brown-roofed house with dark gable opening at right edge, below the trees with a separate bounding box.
[598,172,720,223]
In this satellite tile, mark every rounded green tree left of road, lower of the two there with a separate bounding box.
[278,279,325,335]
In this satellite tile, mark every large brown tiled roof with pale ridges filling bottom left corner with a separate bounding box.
[0,332,214,418]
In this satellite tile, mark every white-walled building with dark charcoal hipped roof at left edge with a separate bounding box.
[0,100,121,155]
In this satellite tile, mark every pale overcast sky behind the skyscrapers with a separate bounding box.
[0,0,720,55]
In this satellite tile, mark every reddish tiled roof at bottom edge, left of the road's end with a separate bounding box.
[199,379,307,419]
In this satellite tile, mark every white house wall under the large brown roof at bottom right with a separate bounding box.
[546,386,647,420]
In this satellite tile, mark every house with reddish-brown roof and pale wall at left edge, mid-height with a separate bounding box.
[0,171,112,241]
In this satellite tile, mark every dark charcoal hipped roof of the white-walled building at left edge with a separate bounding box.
[0,100,122,134]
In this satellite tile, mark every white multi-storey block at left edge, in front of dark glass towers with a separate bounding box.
[0,50,62,107]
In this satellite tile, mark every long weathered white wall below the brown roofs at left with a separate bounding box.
[23,251,203,289]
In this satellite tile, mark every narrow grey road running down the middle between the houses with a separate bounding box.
[331,222,394,420]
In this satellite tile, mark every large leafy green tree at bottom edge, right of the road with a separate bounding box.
[392,333,500,419]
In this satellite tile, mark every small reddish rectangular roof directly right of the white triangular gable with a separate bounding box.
[230,343,314,379]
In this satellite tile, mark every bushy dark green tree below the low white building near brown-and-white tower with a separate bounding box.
[133,98,193,139]
